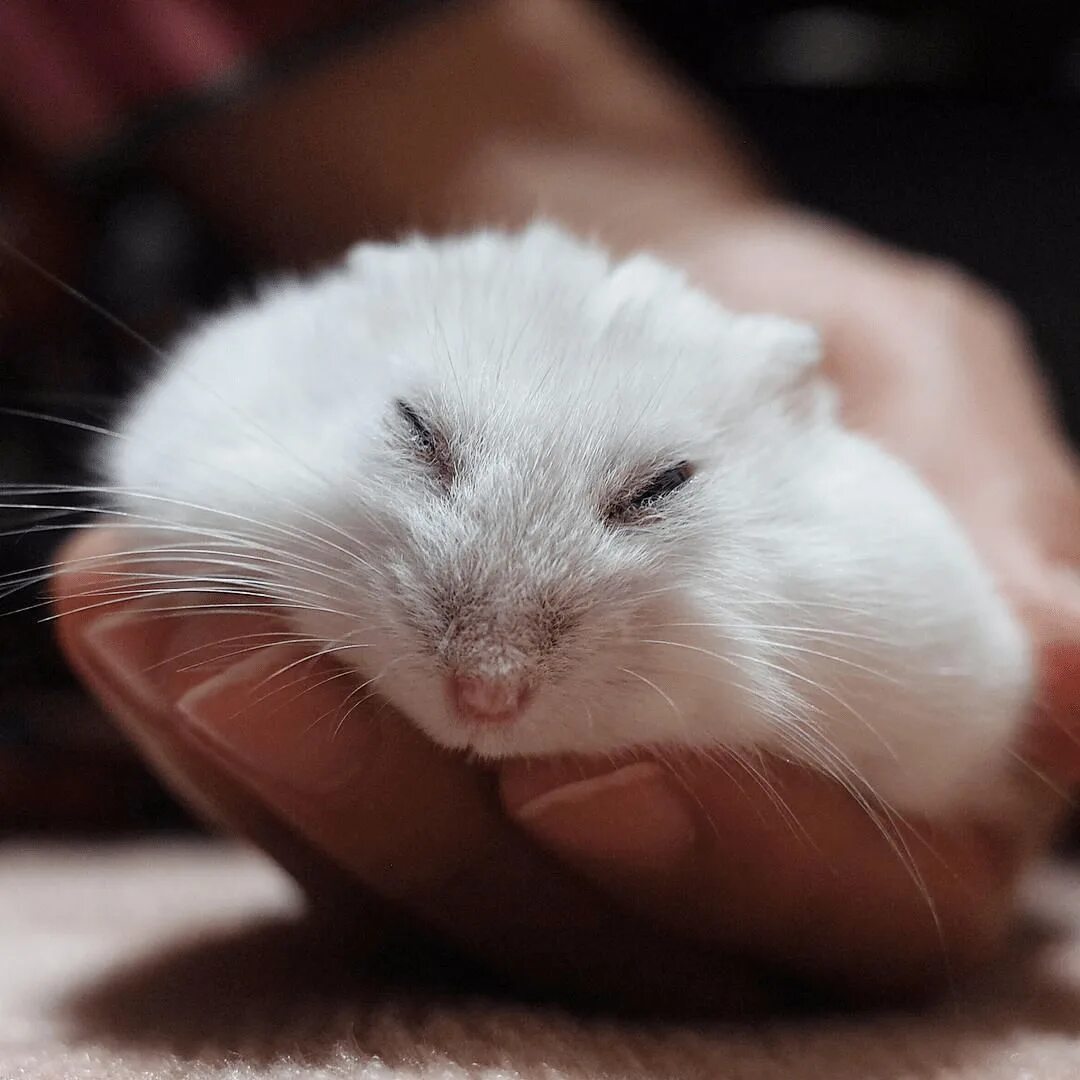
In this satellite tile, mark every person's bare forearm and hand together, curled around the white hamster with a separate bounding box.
[55,0,1080,1010]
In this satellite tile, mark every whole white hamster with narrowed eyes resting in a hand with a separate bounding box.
[106,224,1031,814]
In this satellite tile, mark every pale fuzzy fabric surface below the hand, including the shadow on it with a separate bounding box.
[6,841,1080,1080]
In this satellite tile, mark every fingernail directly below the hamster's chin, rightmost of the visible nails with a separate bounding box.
[503,761,698,872]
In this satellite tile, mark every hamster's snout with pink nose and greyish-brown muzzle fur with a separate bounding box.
[395,537,635,754]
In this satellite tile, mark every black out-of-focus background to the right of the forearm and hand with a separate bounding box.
[610,0,1080,441]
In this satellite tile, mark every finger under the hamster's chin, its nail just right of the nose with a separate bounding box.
[502,760,1054,994]
